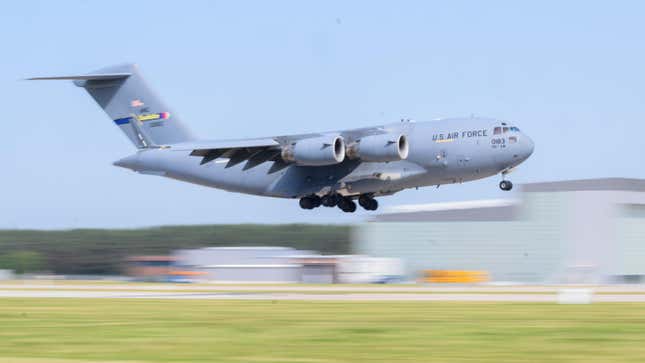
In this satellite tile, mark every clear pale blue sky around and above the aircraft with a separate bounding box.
[0,1,645,228]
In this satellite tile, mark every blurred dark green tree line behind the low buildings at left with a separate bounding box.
[0,224,351,275]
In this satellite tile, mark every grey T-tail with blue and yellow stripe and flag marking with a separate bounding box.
[29,64,194,149]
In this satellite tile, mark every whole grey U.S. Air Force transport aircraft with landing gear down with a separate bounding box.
[30,64,533,212]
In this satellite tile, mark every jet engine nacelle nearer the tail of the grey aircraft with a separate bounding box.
[282,136,345,166]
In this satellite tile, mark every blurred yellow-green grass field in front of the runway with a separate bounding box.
[0,299,645,363]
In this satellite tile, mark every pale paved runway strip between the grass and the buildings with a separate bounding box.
[0,283,645,302]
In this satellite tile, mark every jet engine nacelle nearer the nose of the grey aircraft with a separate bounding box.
[347,134,409,162]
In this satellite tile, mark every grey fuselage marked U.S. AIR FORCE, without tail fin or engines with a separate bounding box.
[115,118,533,198]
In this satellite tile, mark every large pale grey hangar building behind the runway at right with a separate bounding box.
[354,178,645,283]
